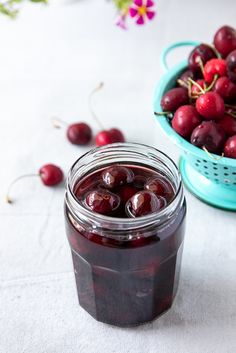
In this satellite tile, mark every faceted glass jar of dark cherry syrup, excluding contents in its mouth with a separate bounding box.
[65,143,186,327]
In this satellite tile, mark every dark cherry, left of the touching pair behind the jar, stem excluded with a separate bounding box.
[66,123,92,145]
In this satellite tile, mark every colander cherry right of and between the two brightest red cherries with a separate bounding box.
[214,76,236,103]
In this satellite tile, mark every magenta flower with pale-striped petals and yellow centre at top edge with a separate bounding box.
[129,0,155,25]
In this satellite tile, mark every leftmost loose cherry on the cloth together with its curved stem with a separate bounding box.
[6,164,63,203]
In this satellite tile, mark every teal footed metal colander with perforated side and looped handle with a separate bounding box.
[154,41,236,211]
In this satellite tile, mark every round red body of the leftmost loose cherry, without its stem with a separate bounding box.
[39,164,63,186]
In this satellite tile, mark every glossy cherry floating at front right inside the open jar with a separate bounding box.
[126,191,166,217]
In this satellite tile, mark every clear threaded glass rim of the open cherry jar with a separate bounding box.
[65,143,183,230]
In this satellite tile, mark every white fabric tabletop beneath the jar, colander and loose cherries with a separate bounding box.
[0,0,236,353]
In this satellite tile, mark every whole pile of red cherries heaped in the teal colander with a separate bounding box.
[156,26,236,158]
